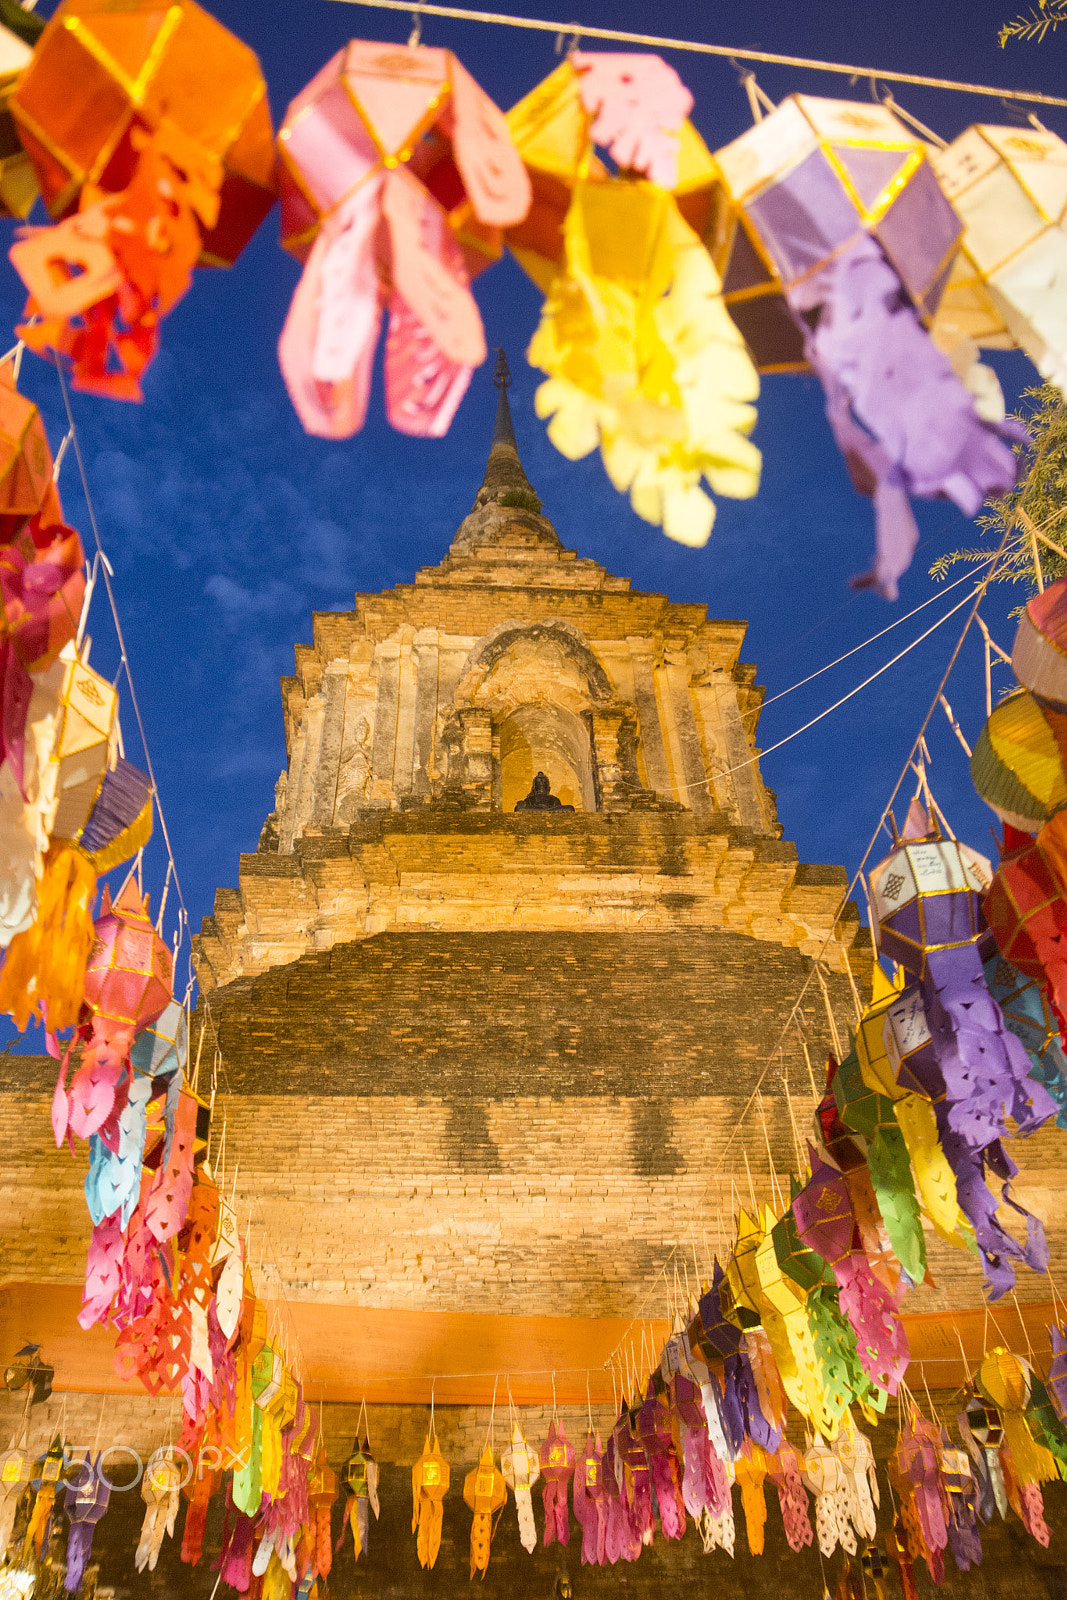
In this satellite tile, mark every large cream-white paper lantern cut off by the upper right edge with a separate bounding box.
[931,123,1067,389]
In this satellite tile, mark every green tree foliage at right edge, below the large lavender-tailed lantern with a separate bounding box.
[929,380,1067,600]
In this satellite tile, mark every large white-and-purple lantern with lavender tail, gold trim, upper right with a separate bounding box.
[715,94,1025,600]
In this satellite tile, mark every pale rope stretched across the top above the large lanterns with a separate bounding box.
[323,0,1067,106]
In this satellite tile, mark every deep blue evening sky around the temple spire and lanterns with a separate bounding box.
[0,0,1067,1017]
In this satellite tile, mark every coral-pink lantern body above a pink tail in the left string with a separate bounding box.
[85,878,173,1037]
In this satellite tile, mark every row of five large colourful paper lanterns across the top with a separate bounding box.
[0,0,1067,598]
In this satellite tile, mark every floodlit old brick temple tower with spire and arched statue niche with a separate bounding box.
[0,389,1067,1600]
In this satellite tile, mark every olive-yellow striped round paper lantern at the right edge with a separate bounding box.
[971,690,1067,834]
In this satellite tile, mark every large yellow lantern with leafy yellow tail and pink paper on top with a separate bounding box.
[507,51,760,546]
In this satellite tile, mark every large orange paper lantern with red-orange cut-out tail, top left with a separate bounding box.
[11,0,275,400]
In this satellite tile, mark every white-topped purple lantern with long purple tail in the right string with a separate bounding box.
[870,802,1056,1298]
